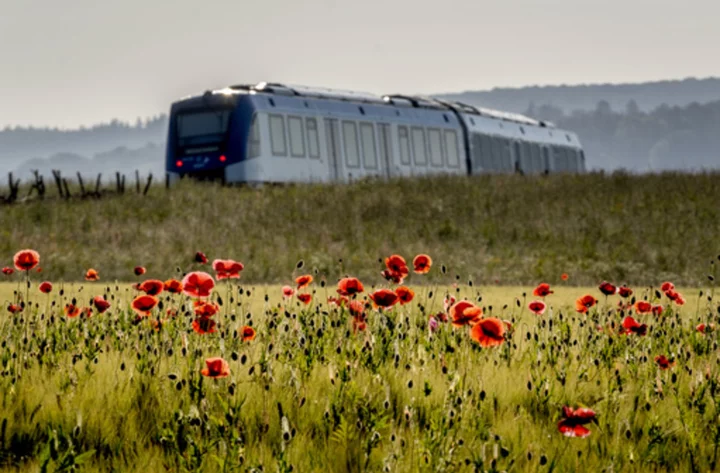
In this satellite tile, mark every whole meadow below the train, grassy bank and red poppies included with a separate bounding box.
[0,171,720,472]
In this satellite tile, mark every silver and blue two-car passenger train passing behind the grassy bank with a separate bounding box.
[166,82,585,184]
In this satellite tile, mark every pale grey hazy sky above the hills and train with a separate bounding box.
[0,0,720,127]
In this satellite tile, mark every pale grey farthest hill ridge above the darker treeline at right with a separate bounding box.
[436,77,720,113]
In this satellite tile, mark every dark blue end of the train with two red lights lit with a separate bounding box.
[165,89,252,183]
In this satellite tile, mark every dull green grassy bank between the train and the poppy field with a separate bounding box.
[0,173,720,286]
